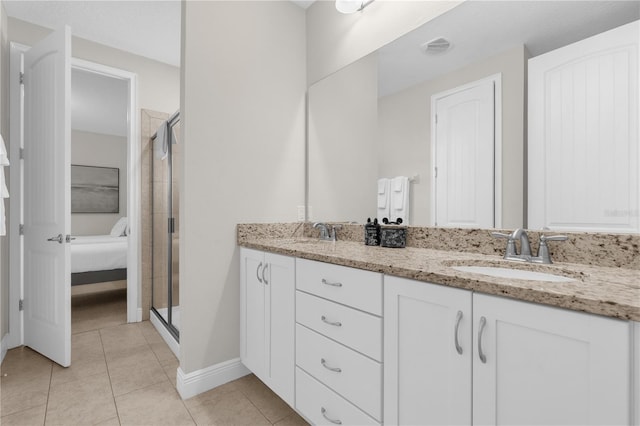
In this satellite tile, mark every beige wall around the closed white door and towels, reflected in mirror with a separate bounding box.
[378,46,529,228]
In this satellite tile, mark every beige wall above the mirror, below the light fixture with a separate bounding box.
[307,0,462,85]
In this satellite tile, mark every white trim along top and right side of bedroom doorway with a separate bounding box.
[71,58,142,322]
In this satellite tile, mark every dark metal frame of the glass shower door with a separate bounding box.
[151,111,180,343]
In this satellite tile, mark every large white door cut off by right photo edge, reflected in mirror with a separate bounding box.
[528,21,640,233]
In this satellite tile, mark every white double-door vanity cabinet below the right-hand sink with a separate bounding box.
[384,276,631,425]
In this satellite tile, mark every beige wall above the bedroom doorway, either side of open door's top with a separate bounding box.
[9,18,180,115]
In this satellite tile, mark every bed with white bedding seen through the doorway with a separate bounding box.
[71,221,128,286]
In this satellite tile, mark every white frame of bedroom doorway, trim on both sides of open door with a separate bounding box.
[9,43,141,360]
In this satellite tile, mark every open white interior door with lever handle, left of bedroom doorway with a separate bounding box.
[24,27,71,367]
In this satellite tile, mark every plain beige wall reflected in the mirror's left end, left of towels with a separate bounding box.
[308,53,378,223]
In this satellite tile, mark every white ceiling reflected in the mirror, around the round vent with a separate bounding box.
[378,0,640,96]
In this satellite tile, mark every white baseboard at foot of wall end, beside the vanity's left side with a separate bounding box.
[176,358,251,399]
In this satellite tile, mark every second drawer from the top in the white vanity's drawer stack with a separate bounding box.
[296,291,382,361]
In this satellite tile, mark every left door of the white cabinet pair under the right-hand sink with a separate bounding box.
[384,276,472,425]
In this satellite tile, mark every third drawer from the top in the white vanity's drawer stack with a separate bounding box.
[296,324,382,421]
